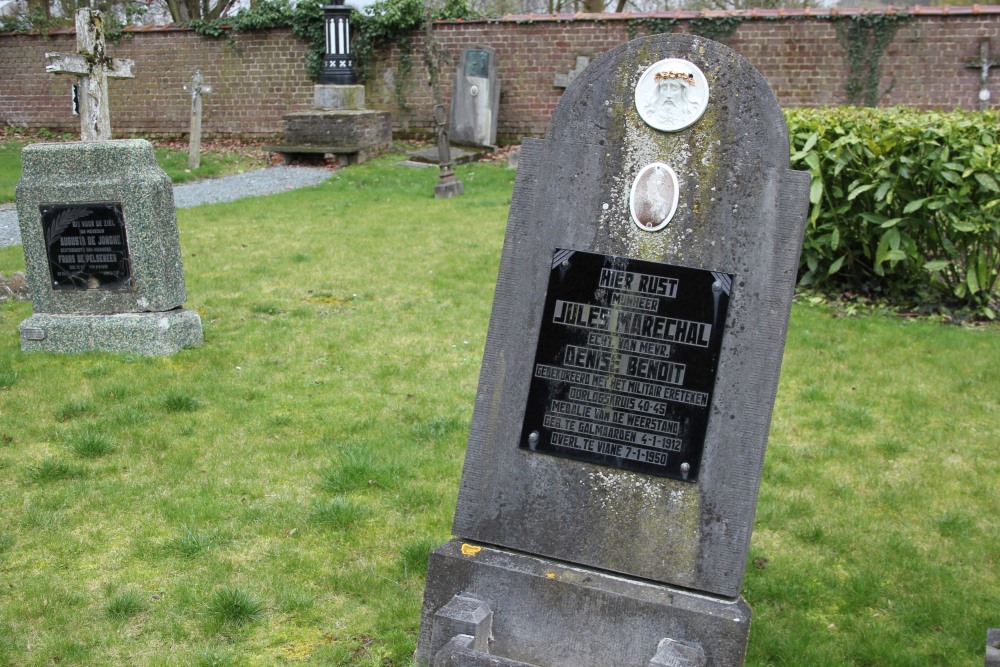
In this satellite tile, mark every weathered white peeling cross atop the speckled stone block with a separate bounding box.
[45,9,134,141]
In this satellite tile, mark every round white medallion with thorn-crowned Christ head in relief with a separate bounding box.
[635,58,708,132]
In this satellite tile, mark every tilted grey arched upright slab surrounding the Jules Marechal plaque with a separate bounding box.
[453,35,810,600]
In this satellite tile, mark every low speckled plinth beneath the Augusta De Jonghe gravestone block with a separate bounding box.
[19,308,203,356]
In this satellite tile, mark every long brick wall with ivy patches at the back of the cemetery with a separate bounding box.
[0,6,1000,141]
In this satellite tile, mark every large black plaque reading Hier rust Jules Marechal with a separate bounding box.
[519,250,732,482]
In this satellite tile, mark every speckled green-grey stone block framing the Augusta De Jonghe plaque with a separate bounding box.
[16,139,186,314]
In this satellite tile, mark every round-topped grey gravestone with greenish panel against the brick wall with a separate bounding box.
[448,46,500,149]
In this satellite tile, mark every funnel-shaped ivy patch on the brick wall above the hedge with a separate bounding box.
[834,12,911,107]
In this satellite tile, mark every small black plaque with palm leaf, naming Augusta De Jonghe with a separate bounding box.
[39,202,132,290]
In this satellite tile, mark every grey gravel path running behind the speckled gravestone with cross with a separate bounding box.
[0,166,333,248]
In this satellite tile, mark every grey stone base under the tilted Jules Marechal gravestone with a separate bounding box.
[416,539,751,667]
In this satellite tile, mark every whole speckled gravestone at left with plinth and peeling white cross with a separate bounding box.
[16,10,202,355]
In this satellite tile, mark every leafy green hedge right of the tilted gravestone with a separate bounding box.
[785,108,1000,319]
